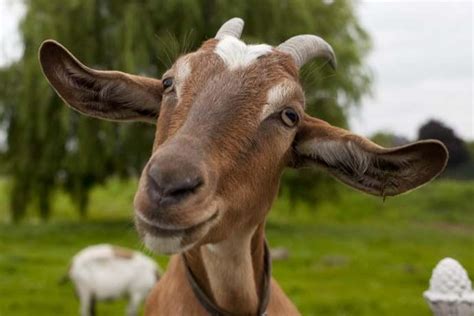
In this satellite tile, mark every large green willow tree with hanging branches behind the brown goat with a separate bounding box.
[0,0,370,220]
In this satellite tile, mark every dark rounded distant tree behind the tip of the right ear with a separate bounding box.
[418,120,469,168]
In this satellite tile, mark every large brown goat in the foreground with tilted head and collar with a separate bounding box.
[39,18,448,315]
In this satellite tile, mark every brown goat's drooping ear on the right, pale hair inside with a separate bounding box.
[293,115,448,196]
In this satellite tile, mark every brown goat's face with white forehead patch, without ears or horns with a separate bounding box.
[135,37,304,250]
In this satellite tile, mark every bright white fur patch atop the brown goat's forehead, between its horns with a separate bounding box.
[214,36,272,70]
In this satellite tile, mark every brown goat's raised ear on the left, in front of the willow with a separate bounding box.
[39,40,163,123]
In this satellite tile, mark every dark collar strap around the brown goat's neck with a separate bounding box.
[182,240,272,316]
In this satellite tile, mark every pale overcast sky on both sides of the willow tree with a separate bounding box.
[0,0,474,140]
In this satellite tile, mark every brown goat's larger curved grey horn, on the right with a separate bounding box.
[277,35,337,69]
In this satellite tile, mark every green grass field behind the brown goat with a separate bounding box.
[0,180,474,316]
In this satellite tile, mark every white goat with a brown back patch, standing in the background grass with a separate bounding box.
[68,244,161,316]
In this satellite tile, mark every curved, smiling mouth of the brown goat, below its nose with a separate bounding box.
[135,209,219,237]
